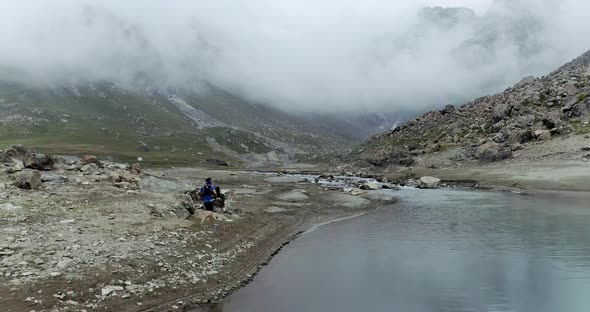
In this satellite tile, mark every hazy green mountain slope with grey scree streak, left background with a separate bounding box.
[0,82,358,165]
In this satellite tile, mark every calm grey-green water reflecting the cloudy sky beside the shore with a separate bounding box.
[222,189,590,312]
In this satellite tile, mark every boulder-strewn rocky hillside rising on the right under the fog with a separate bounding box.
[352,52,590,167]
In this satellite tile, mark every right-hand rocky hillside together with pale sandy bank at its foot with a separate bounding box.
[342,52,590,192]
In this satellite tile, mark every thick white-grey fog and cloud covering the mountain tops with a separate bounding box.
[0,0,590,113]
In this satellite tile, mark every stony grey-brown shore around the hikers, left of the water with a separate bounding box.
[0,146,395,311]
